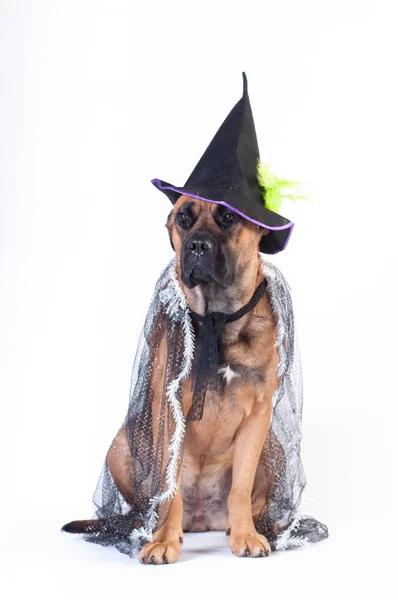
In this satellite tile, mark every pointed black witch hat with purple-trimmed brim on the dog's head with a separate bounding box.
[152,73,293,254]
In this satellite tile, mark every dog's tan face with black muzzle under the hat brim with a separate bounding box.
[166,196,268,288]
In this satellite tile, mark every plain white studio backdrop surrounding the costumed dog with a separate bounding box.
[0,0,398,598]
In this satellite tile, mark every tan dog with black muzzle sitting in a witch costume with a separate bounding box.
[63,195,279,564]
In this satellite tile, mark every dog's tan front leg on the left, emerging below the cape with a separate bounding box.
[139,475,183,565]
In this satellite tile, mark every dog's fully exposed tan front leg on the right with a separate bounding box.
[227,394,272,557]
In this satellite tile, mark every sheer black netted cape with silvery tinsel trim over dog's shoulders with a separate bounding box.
[85,260,328,556]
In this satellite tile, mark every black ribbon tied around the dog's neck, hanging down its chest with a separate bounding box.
[187,279,267,421]
